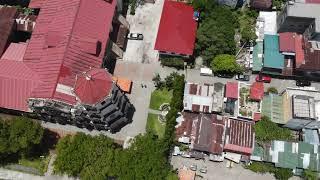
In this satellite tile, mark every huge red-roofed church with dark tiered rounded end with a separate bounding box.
[0,0,134,132]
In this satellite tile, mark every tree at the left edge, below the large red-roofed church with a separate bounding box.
[0,117,44,158]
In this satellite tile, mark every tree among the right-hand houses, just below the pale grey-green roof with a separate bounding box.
[254,116,293,142]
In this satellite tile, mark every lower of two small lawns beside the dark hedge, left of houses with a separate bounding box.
[147,113,166,138]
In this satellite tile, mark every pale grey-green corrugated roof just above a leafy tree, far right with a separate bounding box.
[261,94,286,124]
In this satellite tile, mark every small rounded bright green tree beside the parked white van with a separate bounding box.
[211,54,242,74]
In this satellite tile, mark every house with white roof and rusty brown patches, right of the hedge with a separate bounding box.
[183,82,224,113]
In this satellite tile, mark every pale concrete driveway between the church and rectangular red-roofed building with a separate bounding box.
[123,0,164,63]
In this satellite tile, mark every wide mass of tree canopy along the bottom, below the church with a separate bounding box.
[54,133,170,179]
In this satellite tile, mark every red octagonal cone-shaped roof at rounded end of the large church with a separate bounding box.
[74,69,113,104]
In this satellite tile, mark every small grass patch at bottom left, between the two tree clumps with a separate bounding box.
[18,156,50,175]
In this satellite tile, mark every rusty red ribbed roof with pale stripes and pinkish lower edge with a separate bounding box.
[224,119,255,154]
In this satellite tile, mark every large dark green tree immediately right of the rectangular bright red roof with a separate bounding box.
[195,5,238,61]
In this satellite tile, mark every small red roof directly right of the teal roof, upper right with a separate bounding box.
[279,32,297,52]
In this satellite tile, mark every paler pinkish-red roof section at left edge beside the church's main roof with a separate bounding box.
[1,43,28,61]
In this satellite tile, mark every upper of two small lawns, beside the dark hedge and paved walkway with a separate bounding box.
[149,89,172,110]
